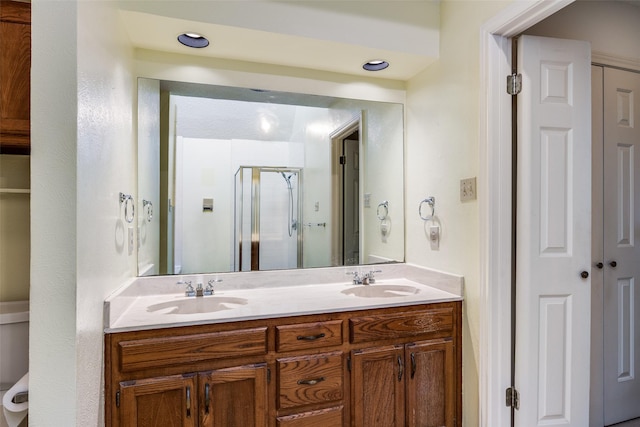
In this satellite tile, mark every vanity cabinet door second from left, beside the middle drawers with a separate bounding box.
[198,364,268,427]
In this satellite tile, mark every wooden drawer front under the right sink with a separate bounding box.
[349,307,454,343]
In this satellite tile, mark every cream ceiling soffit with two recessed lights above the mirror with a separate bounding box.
[120,0,440,81]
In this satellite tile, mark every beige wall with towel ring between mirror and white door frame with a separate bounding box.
[406,0,511,427]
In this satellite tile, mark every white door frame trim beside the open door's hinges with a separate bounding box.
[479,0,573,427]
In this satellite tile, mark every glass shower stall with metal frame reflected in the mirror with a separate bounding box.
[234,166,302,271]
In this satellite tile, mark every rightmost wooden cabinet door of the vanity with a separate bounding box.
[405,340,456,427]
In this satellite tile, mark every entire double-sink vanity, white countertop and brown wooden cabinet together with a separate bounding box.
[105,266,462,427]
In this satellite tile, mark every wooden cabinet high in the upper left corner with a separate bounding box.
[0,0,31,154]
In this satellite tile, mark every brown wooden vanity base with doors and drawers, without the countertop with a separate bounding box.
[105,302,462,427]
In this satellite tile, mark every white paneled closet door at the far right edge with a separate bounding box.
[597,68,640,425]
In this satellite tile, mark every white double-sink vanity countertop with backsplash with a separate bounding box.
[105,264,463,332]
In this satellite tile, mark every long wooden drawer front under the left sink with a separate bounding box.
[118,327,267,372]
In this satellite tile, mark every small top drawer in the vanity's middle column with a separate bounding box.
[276,320,342,351]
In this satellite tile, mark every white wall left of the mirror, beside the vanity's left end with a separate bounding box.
[29,0,136,426]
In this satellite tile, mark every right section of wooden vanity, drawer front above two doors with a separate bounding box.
[350,307,460,427]
